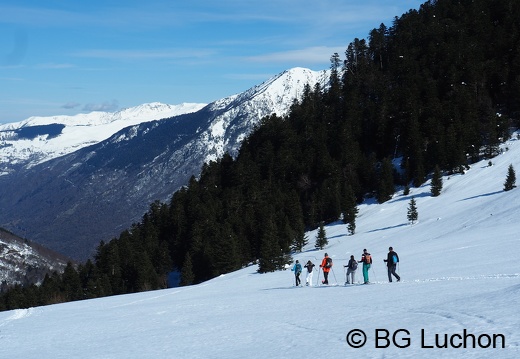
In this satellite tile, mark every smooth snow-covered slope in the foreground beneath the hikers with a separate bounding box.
[0,134,520,359]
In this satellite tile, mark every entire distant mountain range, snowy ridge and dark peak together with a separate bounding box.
[0,68,328,260]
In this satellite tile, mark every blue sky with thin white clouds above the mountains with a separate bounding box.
[0,0,424,123]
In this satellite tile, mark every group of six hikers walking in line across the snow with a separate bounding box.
[291,247,401,287]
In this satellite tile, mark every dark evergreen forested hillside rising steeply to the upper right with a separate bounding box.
[0,0,520,308]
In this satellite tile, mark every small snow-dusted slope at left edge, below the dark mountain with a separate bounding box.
[0,228,67,289]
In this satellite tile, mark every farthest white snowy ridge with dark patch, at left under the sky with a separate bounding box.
[0,102,206,174]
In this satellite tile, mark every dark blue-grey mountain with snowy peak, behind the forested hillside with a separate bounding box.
[0,68,328,259]
